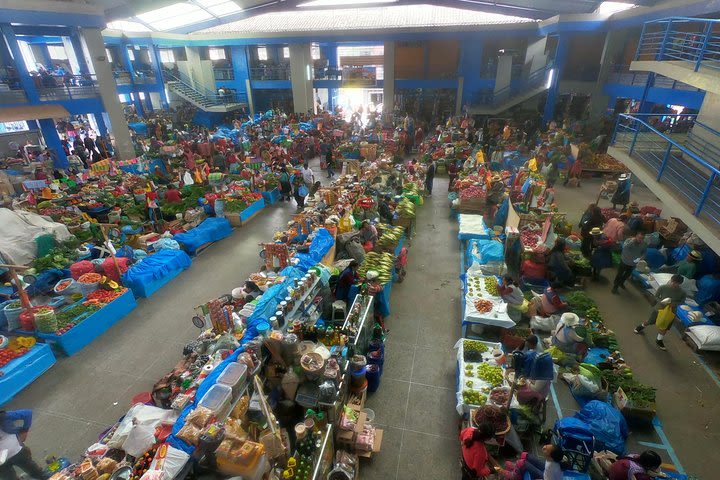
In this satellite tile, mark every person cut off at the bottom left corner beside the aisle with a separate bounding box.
[0,410,48,480]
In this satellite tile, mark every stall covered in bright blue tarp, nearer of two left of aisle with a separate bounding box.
[122,249,192,298]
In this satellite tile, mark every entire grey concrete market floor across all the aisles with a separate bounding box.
[8,167,720,480]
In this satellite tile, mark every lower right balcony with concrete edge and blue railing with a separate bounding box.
[609,114,720,249]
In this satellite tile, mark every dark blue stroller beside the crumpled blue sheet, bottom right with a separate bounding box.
[553,418,595,480]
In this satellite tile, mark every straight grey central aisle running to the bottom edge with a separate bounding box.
[361,178,460,480]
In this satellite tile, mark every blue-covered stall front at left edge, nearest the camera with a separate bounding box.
[0,343,56,405]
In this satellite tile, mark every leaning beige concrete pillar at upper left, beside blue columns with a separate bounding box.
[81,28,135,160]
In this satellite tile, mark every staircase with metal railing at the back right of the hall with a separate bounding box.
[467,63,554,115]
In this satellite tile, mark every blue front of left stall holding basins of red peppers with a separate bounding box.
[37,290,137,356]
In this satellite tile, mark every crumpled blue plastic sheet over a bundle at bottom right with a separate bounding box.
[556,400,628,455]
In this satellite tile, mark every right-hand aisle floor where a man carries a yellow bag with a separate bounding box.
[556,181,720,479]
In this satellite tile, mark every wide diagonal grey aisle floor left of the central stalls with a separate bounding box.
[7,198,306,461]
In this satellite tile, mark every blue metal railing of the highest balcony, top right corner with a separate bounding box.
[635,17,720,72]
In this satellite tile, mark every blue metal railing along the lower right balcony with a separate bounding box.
[612,114,720,226]
